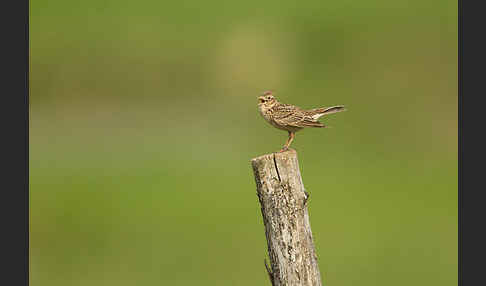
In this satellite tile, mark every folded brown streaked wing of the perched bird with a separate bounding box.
[273,104,324,127]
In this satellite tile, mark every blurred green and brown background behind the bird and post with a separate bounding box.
[30,0,458,286]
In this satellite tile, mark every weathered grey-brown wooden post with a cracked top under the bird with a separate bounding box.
[251,149,322,286]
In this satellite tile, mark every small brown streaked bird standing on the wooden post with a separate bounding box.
[258,91,346,152]
